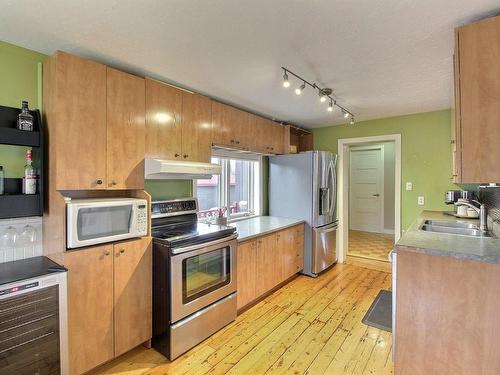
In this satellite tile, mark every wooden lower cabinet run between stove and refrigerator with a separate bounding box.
[237,224,304,309]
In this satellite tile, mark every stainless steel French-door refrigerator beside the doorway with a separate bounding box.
[269,151,338,277]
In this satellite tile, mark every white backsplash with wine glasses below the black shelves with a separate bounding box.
[0,217,42,263]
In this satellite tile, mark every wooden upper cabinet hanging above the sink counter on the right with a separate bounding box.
[454,16,500,183]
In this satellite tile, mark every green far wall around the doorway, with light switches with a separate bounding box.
[313,110,457,230]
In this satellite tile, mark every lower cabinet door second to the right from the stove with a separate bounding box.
[255,234,281,296]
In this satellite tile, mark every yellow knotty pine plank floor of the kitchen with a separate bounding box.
[93,264,393,375]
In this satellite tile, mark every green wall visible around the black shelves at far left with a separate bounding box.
[0,41,46,178]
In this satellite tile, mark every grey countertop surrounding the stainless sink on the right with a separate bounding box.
[394,211,500,264]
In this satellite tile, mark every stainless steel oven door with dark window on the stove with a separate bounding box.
[170,235,237,323]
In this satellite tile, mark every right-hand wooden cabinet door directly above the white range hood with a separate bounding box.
[182,92,212,162]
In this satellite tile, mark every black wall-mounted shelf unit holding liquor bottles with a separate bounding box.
[0,106,44,219]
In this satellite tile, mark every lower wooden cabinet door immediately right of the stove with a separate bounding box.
[236,241,257,309]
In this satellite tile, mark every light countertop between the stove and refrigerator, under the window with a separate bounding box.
[229,216,304,242]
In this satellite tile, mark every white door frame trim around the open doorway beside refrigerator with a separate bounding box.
[337,134,401,263]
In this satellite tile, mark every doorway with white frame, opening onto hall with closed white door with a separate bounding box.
[338,134,401,263]
